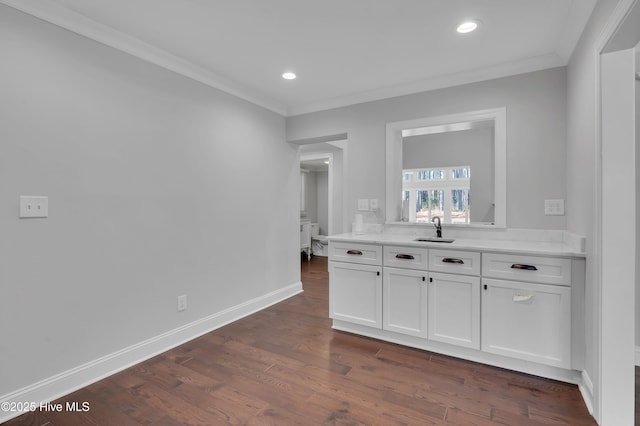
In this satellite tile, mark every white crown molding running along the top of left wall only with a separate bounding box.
[0,0,286,115]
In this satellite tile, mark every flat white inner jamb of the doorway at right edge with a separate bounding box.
[599,49,637,425]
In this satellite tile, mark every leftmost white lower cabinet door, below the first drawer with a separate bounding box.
[329,262,382,328]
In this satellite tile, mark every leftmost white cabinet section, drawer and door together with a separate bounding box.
[329,243,382,329]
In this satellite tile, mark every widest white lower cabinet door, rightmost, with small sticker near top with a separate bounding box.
[482,278,571,368]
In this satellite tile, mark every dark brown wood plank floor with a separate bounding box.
[7,257,595,426]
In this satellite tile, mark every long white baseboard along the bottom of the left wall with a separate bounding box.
[0,281,303,423]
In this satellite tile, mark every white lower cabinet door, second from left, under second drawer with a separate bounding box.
[382,267,427,338]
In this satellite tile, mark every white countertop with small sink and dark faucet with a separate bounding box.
[328,231,586,258]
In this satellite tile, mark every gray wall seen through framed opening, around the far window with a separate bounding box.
[402,127,495,222]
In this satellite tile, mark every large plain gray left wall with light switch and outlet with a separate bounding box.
[0,5,300,395]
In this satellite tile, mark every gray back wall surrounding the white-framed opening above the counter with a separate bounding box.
[287,68,566,230]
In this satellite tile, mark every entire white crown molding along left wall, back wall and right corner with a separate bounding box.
[0,0,584,117]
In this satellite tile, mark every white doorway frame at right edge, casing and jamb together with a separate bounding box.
[593,0,639,425]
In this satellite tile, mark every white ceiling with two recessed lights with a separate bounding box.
[0,0,596,115]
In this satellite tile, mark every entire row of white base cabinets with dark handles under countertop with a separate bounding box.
[329,241,584,381]
